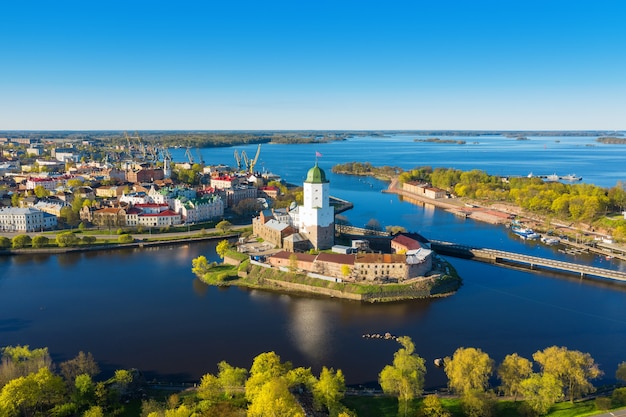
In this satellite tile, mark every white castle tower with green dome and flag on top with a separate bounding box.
[299,162,335,249]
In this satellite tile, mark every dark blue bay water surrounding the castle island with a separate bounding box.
[0,137,626,387]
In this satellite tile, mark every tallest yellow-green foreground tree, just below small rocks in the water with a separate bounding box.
[378,336,426,416]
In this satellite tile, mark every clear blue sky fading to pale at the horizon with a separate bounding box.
[0,0,626,131]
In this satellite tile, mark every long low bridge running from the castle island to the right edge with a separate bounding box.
[430,240,626,283]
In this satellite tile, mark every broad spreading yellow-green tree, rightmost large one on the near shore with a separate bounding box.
[533,346,602,402]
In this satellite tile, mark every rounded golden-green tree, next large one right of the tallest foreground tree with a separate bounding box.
[444,348,494,394]
